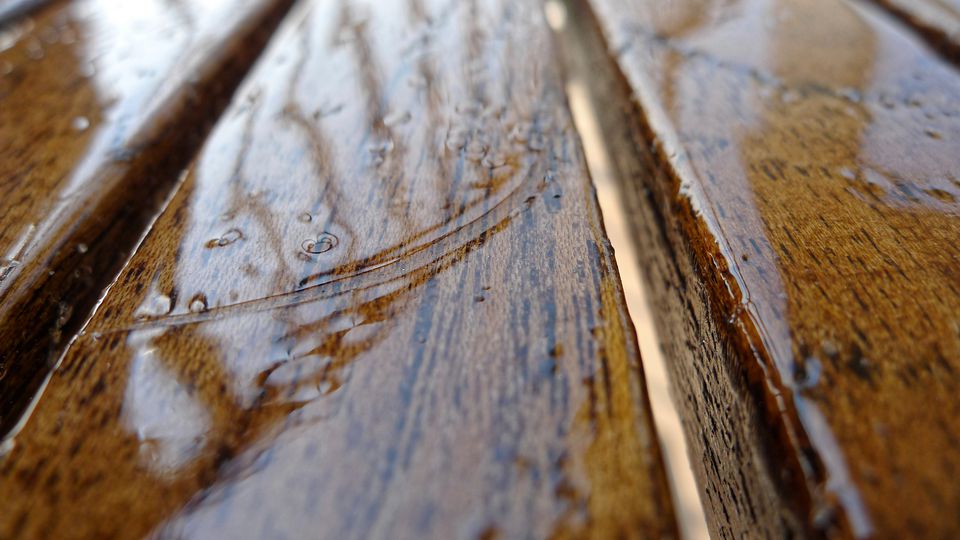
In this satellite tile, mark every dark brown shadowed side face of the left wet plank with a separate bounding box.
[0,0,297,439]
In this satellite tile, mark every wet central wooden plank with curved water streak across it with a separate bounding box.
[0,0,676,539]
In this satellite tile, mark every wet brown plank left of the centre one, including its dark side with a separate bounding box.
[0,0,291,436]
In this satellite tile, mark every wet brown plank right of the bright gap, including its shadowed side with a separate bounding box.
[568,0,960,538]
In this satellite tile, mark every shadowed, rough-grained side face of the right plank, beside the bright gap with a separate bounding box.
[563,0,821,538]
